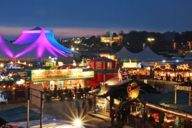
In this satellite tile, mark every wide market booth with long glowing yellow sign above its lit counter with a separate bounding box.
[31,68,94,90]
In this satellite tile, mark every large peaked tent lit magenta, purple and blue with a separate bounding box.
[13,27,75,58]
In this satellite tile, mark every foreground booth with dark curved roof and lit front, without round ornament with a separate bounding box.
[95,77,131,113]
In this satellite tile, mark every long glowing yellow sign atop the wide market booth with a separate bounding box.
[31,68,94,81]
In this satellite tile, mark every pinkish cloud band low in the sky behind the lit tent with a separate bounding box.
[0,26,129,37]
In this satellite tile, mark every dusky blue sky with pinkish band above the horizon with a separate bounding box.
[0,0,192,37]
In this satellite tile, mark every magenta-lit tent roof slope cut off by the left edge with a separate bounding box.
[0,35,13,58]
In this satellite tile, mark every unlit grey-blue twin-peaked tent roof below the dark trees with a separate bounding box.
[116,47,163,61]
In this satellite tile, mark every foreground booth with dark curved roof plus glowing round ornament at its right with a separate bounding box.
[95,77,140,123]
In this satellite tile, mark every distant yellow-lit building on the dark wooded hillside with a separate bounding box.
[100,32,123,45]
